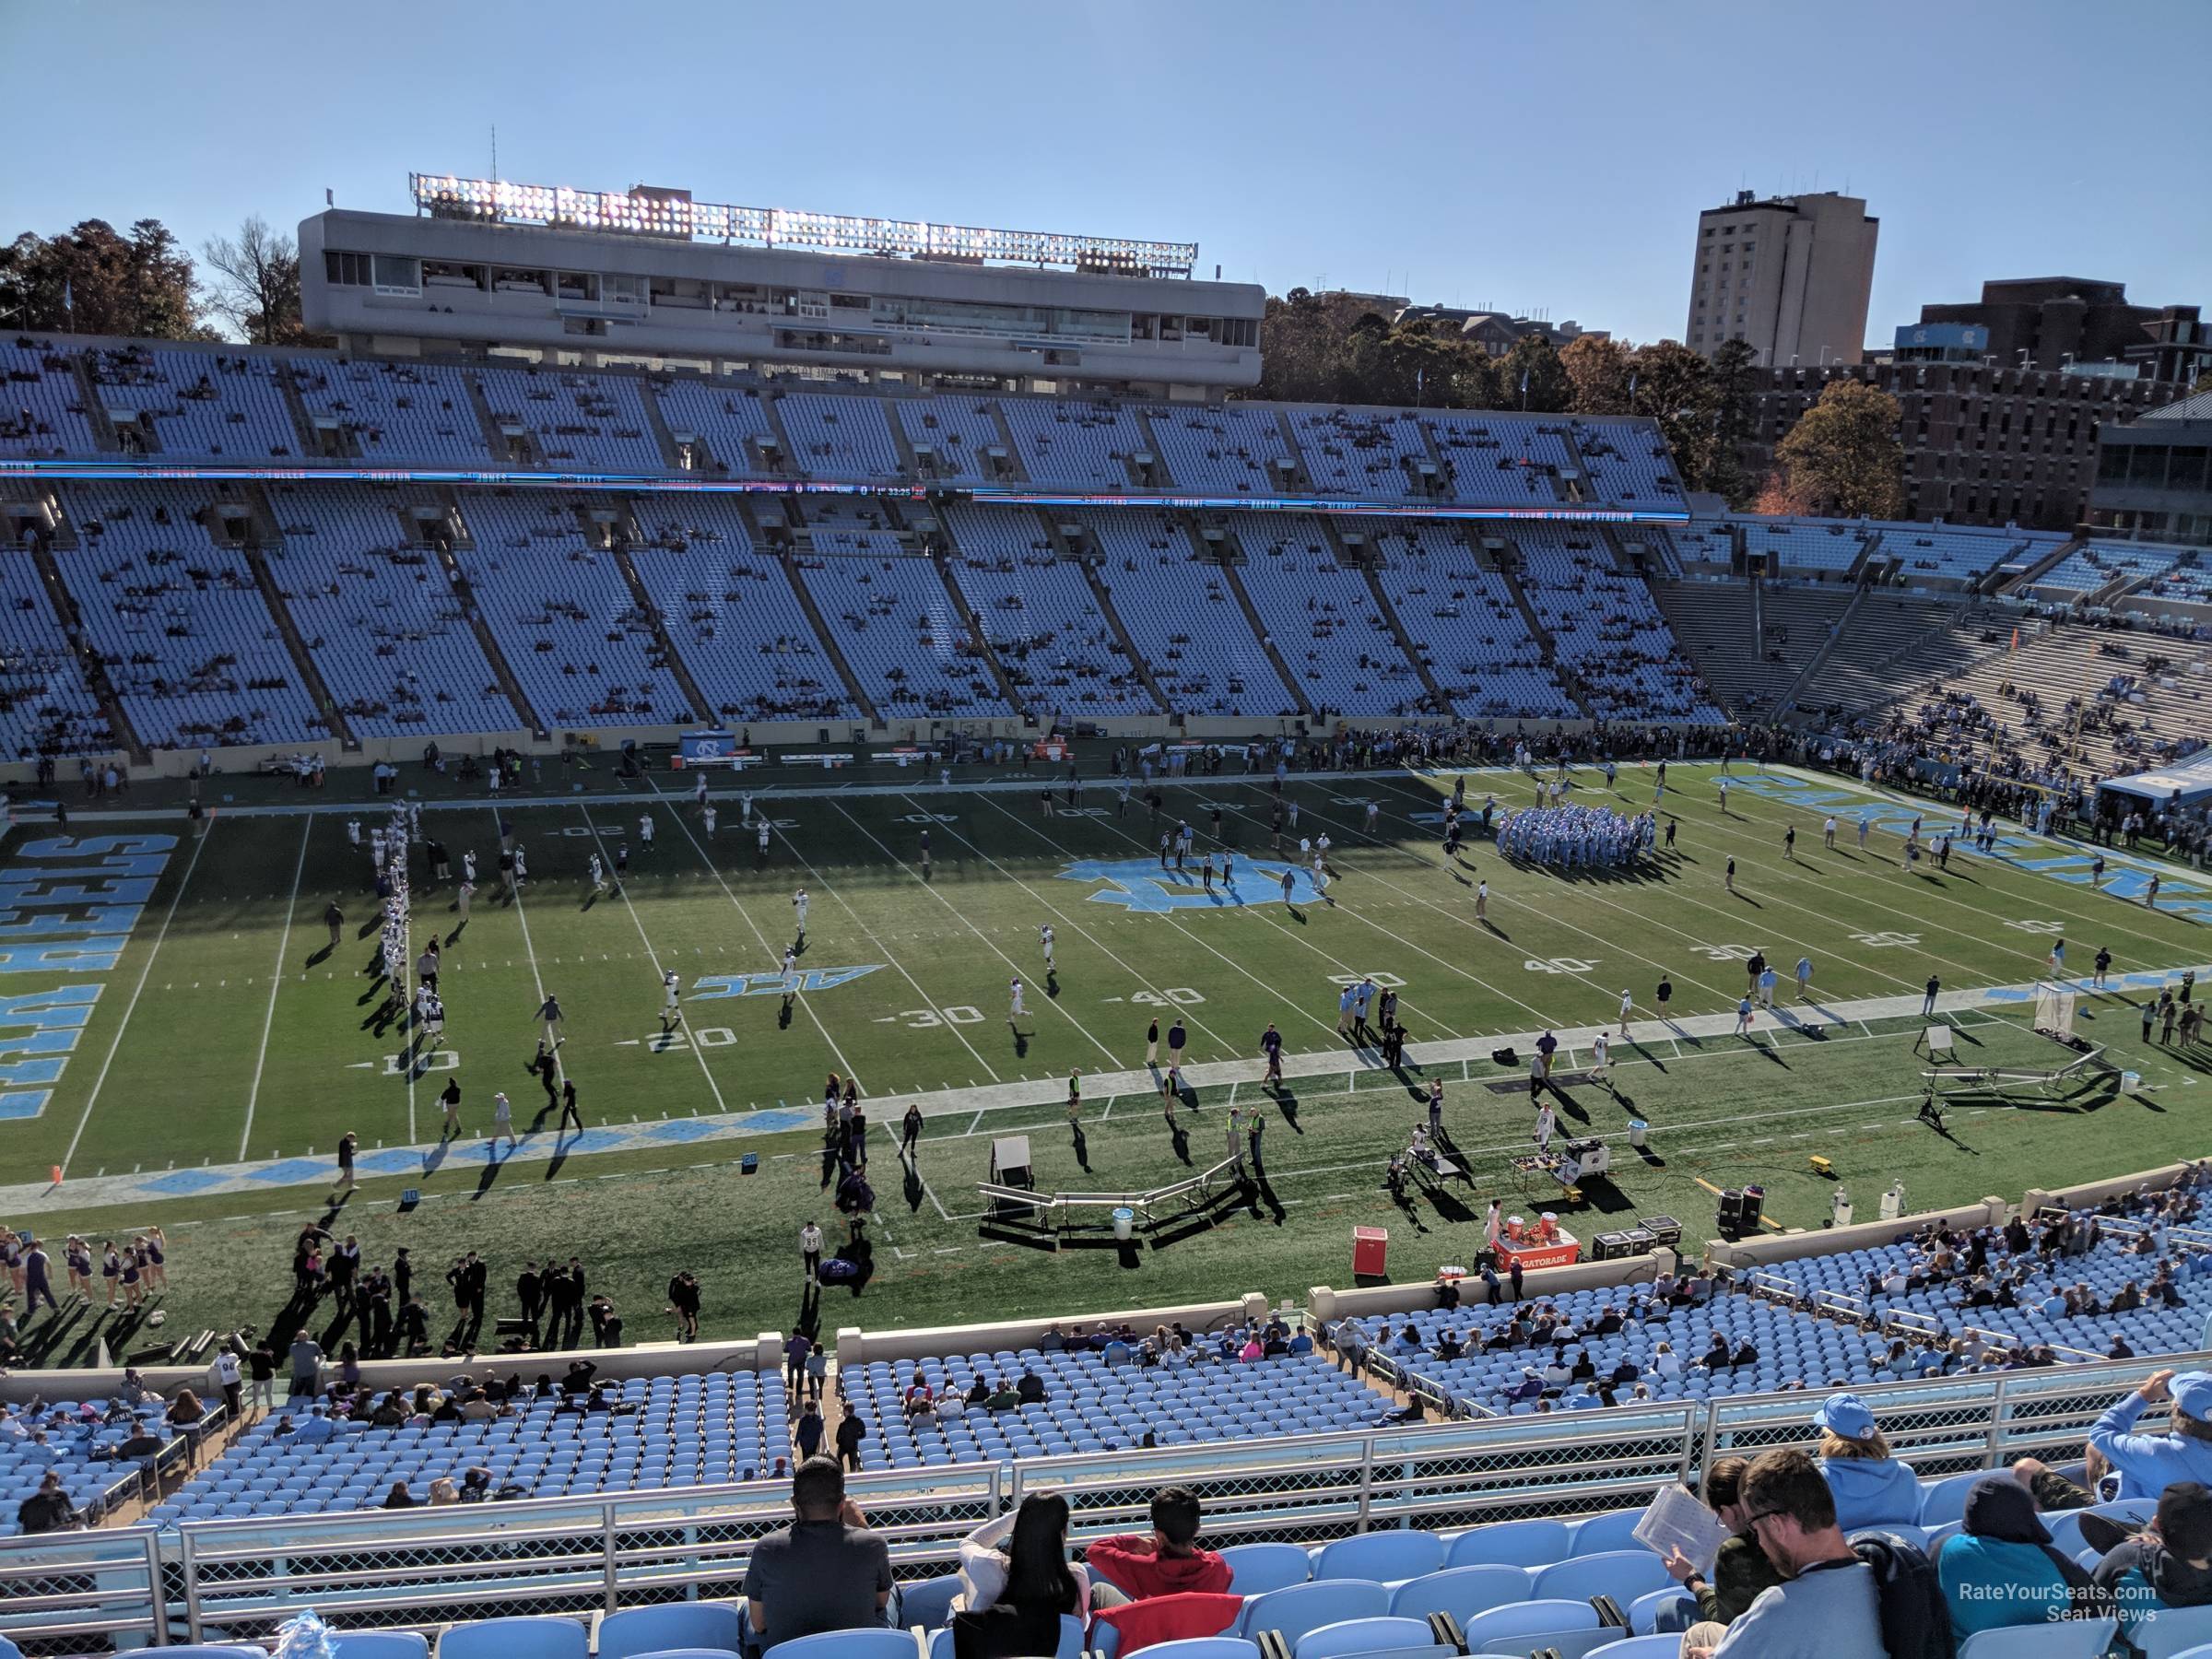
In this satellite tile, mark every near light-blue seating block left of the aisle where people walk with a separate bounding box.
[149,1371,790,1524]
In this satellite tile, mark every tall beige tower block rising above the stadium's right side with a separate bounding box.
[1683,190,1882,370]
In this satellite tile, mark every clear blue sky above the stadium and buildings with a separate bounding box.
[0,0,2212,338]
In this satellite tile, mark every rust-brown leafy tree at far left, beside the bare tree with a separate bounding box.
[0,219,212,341]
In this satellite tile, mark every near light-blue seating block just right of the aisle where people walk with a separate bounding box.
[845,1347,1389,1469]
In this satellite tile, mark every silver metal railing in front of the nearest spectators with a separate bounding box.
[0,1354,2212,1654]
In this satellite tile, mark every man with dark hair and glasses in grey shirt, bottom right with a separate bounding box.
[1681,1449,1889,1659]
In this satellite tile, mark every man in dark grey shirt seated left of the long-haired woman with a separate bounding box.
[743,1458,891,1648]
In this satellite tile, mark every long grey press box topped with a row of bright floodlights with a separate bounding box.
[299,175,1267,400]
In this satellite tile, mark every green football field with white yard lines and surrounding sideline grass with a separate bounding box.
[0,768,2206,1362]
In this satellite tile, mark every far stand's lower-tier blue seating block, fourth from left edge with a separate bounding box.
[453,491,695,725]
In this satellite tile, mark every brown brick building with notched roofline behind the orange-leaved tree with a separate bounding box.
[1743,362,2181,529]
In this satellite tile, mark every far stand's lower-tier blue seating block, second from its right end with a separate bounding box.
[1376,524,1582,719]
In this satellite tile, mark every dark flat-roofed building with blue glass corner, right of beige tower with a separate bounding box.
[1920,276,2212,382]
